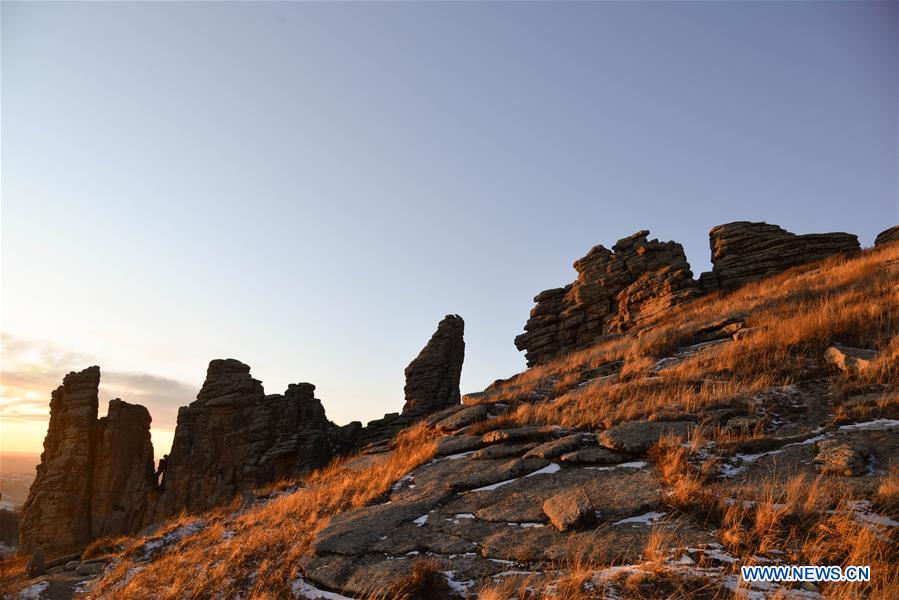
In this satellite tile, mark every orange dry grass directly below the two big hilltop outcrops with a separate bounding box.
[472,244,899,436]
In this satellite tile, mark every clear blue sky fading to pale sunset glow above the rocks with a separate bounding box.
[0,1,899,455]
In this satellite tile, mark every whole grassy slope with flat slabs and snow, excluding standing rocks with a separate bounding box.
[1,244,899,599]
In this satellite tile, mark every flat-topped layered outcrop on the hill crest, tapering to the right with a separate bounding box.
[700,221,860,291]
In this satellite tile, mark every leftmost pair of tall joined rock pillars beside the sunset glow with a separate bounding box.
[19,367,155,555]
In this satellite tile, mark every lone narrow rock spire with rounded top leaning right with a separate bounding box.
[403,315,465,416]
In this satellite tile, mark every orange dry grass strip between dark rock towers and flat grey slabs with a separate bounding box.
[90,424,435,599]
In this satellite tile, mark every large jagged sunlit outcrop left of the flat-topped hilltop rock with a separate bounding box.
[515,230,700,366]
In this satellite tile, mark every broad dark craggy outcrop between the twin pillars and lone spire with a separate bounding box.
[153,359,360,520]
